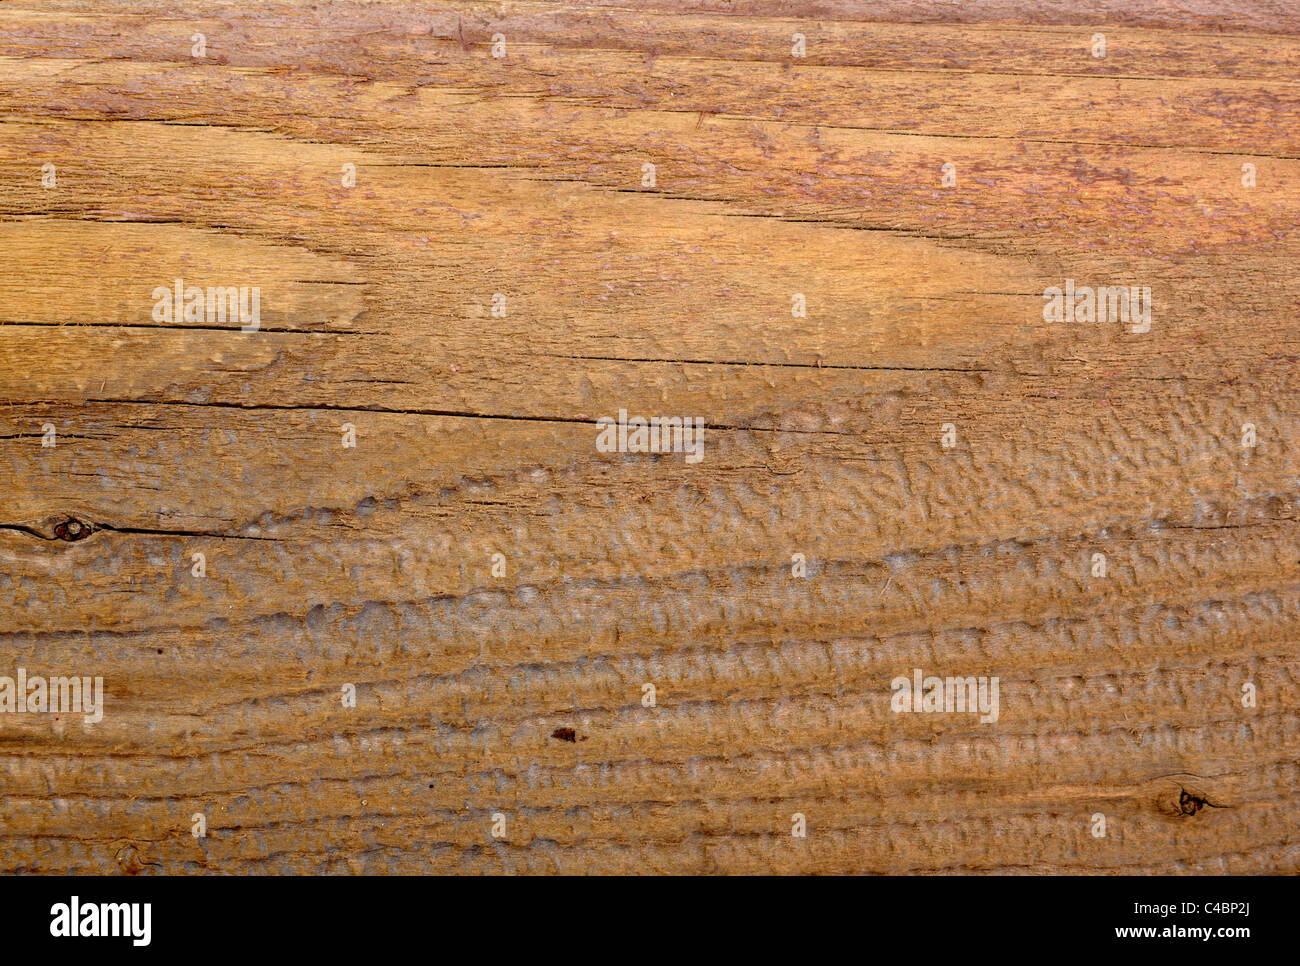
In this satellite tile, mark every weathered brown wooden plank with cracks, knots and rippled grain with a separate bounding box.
[0,0,1300,874]
